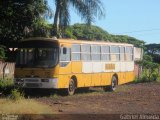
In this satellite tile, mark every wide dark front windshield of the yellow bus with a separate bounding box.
[16,47,58,68]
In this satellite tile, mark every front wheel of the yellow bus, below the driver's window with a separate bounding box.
[67,78,76,95]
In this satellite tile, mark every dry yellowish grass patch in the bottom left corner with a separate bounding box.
[0,99,53,114]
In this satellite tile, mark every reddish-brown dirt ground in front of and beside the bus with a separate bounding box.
[36,82,160,114]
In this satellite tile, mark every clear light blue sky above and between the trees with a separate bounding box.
[48,0,160,44]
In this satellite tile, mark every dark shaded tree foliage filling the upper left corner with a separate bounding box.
[0,0,49,46]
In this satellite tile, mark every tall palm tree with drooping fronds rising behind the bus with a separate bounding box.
[54,0,104,34]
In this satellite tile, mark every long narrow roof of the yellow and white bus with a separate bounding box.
[22,37,133,46]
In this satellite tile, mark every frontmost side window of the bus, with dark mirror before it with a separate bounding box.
[60,47,71,67]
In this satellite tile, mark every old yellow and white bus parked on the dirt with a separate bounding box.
[14,37,141,95]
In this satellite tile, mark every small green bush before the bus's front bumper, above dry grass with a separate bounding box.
[9,89,24,101]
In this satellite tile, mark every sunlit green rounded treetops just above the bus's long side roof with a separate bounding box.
[63,24,145,47]
